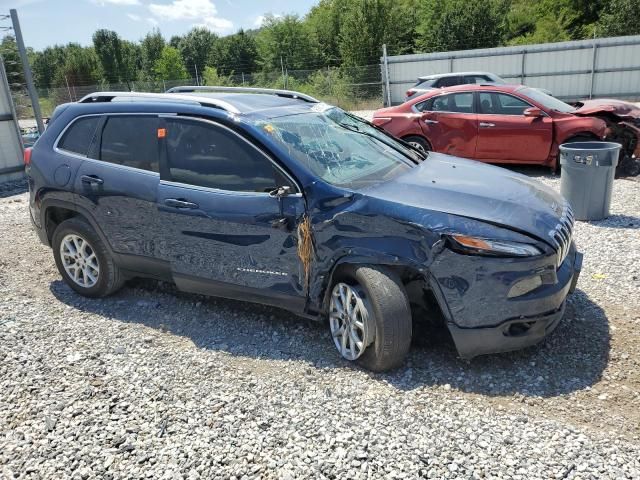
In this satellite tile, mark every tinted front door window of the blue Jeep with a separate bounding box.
[166,119,283,192]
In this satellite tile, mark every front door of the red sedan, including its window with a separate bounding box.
[475,92,553,163]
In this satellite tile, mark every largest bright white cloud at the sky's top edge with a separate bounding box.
[149,0,233,33]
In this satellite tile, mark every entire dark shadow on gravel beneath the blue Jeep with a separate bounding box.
[50,280,610,398]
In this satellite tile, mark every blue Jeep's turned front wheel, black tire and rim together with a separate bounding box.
[329,266,412,372]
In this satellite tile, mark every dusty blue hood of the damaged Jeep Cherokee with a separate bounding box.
[362,152,567,241]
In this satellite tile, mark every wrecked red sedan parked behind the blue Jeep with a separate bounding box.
[373,85,640,169]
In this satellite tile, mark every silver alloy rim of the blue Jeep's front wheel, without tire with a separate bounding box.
[329,283,375,361]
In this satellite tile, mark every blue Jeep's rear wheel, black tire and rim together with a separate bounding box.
[51,217,125,298]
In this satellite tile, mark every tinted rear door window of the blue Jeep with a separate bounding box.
[100,115,160,172]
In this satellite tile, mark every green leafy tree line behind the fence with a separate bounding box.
[3,0,640,93]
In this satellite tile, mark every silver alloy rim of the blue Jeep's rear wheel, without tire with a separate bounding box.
[60,233,100,288]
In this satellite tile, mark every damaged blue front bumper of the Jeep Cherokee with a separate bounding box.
[436,246,582,359]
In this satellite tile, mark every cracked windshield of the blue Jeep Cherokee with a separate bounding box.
[257,108,422,189]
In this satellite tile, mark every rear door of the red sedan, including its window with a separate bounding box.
[416,92,478,158]
